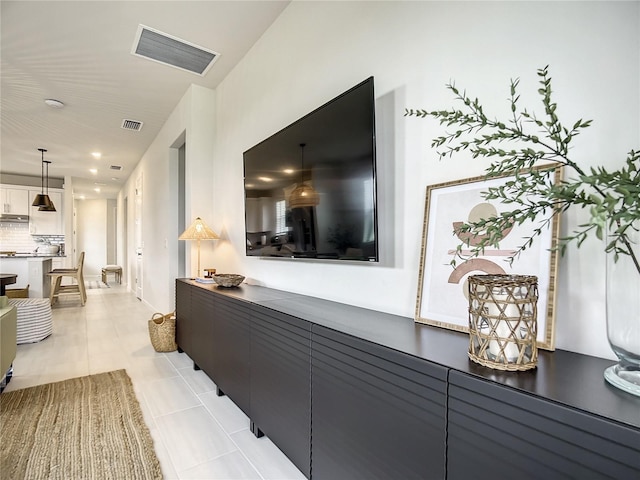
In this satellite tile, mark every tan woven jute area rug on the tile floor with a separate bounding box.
[0,370,162,480]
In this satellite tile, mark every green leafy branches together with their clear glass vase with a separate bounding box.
[405,67,640,395]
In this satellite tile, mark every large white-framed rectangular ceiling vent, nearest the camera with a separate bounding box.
[131,25,220,77]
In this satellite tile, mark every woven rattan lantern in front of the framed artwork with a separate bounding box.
[469,275,538,371]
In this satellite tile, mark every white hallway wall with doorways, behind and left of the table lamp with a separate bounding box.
[118,85,220,312]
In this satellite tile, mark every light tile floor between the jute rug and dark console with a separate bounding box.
[5,282,305,480]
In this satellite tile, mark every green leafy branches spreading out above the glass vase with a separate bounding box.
[405,66,640,274]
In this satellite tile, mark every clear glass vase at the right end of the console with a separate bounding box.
[604,220,640,396]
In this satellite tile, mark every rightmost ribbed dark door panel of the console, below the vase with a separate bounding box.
[447,372,640,480]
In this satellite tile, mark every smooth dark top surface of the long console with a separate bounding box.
[183,280,640,428]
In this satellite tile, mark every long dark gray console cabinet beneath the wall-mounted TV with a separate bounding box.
[176,279,640,480]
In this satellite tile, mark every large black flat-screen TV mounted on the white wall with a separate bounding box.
[243,77,378,262]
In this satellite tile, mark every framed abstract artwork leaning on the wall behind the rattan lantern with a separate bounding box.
[415,165,562,350]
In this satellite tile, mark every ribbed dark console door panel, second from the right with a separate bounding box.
[311,325,447,480]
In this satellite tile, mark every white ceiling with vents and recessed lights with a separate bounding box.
[0,0,289,198]
